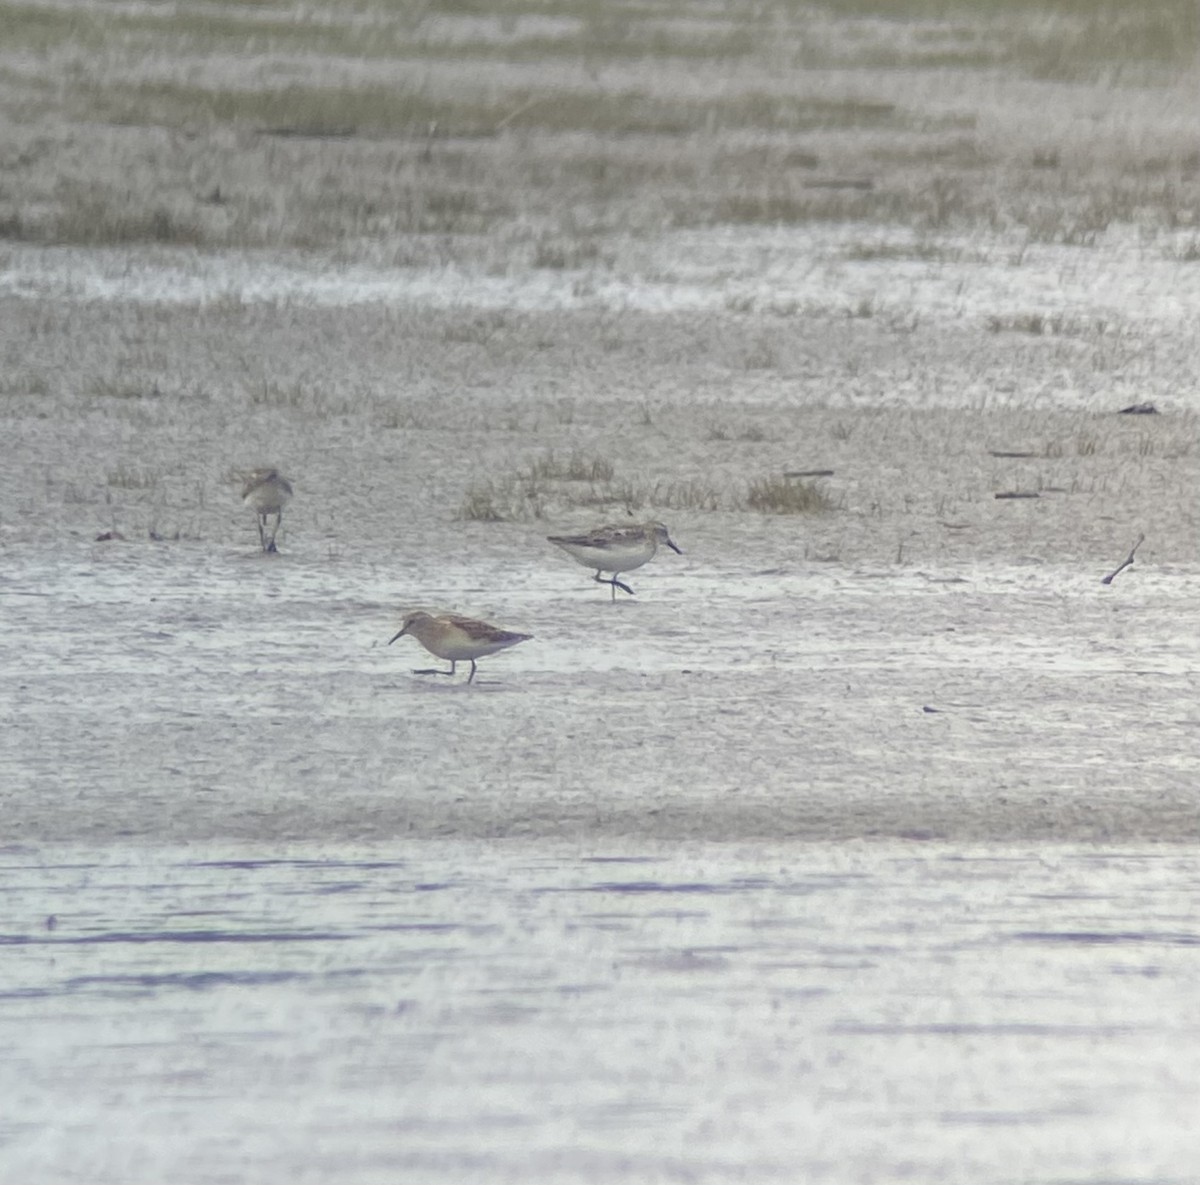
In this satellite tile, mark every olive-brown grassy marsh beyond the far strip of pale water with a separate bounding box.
[0,0,1200,261]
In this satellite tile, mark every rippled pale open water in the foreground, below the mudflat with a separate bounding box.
[0,841,1200,1183]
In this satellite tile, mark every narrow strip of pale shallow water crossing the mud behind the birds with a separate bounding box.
[9,223,1200,333]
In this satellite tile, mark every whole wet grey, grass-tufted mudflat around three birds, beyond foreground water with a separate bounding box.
[0,4,1200,842]
